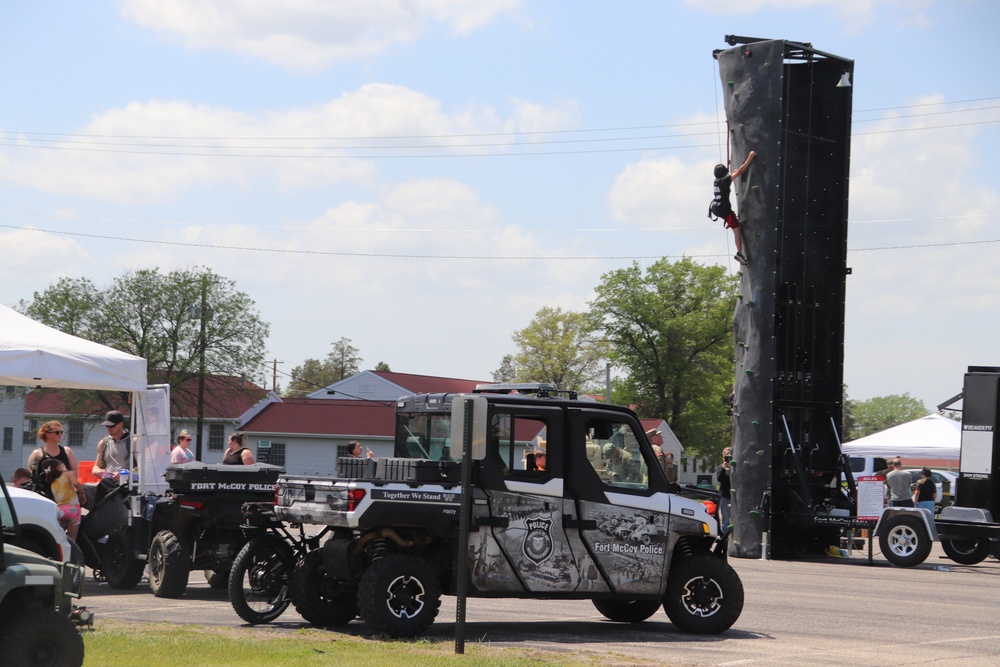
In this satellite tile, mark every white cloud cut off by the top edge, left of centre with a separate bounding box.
[118,0,520,69]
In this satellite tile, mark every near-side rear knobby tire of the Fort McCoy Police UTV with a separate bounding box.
[358,554,441,637]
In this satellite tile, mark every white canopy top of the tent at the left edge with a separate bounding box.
[0,304,146,391]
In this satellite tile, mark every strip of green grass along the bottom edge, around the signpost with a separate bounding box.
[83,620,599,667]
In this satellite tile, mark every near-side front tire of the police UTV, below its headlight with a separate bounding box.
[663,554,743,635]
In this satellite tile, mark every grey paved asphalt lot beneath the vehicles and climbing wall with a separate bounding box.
[82,545,1000,667]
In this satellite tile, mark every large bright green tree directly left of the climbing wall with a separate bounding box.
[590,258,737,454]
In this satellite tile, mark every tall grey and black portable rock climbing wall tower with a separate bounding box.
[716,38,853,558]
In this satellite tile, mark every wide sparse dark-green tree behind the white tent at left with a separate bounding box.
[18,268,270,416]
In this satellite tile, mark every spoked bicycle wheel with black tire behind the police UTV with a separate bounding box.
[229,535,294,625]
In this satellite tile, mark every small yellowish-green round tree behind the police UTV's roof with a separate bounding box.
[512,306,605,390]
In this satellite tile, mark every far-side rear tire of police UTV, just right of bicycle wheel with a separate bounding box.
[290,551,358,627]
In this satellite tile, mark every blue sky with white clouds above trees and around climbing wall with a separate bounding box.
[0,0,1000,409]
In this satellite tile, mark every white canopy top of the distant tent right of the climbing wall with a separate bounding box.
[843,414,962,459]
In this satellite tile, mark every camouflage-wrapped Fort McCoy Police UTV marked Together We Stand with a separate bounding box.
[275,385,743,637]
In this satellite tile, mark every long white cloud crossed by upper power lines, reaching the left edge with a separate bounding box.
[0,83,573,204]
